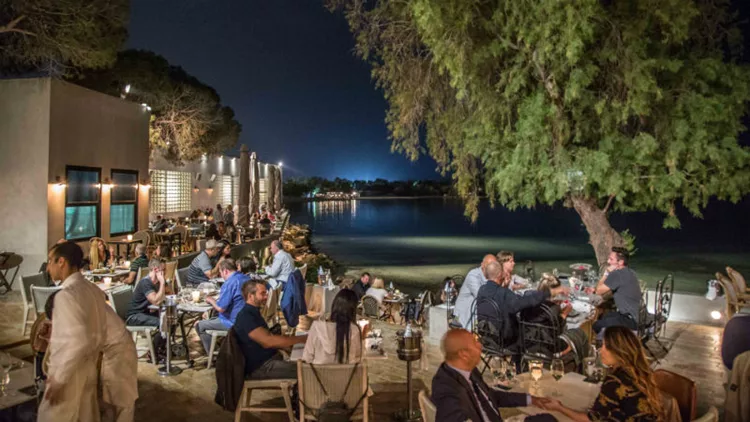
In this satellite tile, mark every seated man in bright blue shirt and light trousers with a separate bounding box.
[196,258,249,359]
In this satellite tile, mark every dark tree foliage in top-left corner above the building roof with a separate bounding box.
[0,0,130,76]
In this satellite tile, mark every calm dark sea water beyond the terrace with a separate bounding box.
[289,198,750,292]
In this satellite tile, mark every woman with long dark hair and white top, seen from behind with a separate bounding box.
[302,289,362,365]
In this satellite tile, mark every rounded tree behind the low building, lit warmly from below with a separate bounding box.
[81,50,241,163]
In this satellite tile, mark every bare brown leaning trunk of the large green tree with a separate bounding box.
[571,196,623,266]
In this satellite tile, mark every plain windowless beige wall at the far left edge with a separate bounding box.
[0,79,51,276]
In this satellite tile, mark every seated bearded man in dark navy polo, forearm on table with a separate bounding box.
[234,280,307,380]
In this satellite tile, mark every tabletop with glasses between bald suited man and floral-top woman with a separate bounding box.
[511,370,601,422]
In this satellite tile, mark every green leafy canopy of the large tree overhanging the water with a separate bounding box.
[328,0,750,263]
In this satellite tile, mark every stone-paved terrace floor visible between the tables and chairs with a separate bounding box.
[0,292,724,422]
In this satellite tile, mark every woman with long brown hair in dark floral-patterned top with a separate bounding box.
[544,327,666,421]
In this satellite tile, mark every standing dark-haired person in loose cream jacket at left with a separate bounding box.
[38,242,137,422]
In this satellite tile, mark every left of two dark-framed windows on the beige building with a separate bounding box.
[65,166,102,240]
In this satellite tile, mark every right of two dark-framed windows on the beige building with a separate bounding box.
[109,170,138,236]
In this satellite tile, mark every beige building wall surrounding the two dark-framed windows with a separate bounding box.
[47,80,150,251]
